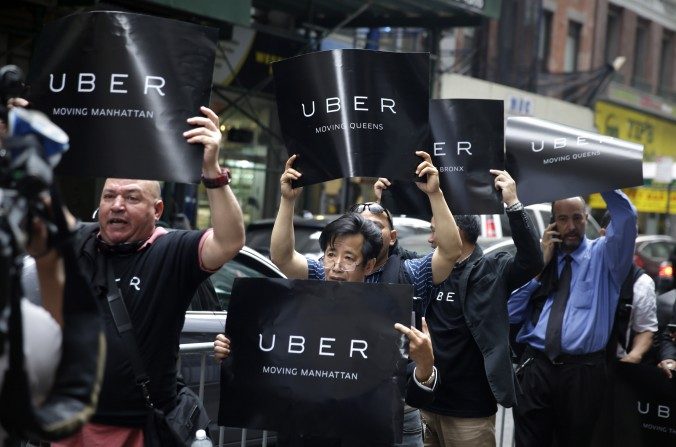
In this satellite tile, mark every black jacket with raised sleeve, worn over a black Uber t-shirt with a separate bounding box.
[432,210,543,407]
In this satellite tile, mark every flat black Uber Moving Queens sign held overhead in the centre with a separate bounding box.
[272,49,429,186]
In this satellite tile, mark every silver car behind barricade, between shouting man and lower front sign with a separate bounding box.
[180,247,285,447]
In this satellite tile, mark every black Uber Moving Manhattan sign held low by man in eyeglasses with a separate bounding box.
[218,278,413,445]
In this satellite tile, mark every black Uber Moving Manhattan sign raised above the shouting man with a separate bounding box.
[28,11,218,183]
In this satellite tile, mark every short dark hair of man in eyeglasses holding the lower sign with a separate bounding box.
[319,213,383,263]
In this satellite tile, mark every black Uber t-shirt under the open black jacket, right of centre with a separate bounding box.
[425,263,497,417]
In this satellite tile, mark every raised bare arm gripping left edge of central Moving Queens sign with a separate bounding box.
[270,155,308,279]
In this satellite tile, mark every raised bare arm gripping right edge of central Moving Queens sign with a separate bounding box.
[415,151,462,284]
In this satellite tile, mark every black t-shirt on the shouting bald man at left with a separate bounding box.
[92,231,210,426]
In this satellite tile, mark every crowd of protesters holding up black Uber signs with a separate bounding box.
[3,92,676,447]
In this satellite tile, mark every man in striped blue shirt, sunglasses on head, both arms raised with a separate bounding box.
[270,151,461,447]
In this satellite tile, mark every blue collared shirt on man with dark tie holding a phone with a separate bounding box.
[508,191,636,354]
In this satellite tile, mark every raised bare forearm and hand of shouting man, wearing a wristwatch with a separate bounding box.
[183,107,244,270]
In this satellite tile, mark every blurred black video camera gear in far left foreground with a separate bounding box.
[0,65,105,445]
